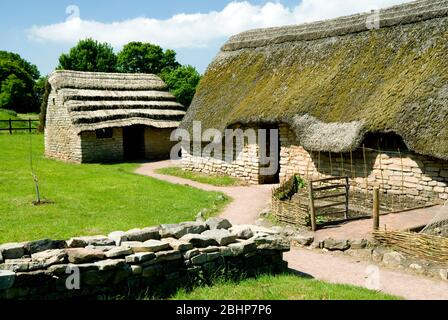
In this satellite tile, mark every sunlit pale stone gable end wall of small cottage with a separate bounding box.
[45,90,82,163]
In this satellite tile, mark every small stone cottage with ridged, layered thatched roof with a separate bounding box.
[45,71,185,163]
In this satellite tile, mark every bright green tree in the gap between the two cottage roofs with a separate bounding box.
[160,65,201,107]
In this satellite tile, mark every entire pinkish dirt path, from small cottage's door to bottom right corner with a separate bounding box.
[136,161,448,300]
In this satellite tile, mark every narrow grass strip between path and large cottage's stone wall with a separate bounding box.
[156,167,245,187]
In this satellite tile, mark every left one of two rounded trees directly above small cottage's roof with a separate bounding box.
[58,39,117,72]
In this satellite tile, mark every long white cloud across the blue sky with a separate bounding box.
[26,0,410,48]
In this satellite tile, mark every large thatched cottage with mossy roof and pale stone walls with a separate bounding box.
[181,0,448,200]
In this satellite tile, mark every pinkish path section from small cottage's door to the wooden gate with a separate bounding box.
[136,160,272,224]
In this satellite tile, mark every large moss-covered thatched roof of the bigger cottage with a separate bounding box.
[181,0,448,159]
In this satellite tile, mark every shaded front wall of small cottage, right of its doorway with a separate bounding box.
[145,127,176,160]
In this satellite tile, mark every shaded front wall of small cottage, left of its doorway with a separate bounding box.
[81,128,123,163]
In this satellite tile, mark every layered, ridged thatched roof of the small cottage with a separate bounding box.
[49,71,185,133]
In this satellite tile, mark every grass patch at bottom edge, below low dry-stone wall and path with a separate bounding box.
[172,274,399,300]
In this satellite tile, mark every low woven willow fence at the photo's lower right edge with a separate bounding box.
[373,231,448,264]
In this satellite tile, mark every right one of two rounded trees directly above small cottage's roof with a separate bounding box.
[117,42,180,74]
